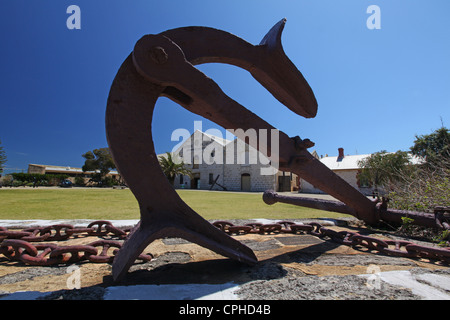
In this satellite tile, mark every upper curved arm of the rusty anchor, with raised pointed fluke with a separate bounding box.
[161,19,317,118]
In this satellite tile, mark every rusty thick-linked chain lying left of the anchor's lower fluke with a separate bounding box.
[0,220,153,266]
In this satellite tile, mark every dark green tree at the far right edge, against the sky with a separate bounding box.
[411,126,450,164]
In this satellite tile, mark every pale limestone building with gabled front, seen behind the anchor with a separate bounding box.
[158,130,299,192]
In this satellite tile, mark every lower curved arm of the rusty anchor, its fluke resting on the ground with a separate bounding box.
[106,56,257,280]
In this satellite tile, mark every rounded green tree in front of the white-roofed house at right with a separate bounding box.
[358,150,409,192]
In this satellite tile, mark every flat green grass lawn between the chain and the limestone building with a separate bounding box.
[0,188,347,220]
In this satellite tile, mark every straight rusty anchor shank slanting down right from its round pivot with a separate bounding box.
[133,31,379,223]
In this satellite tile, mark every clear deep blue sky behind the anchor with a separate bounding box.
[0,0,450,172]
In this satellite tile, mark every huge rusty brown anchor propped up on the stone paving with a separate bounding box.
[106,19,379,280]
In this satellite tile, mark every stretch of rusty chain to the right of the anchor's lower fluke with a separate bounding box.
[213,221,450,263]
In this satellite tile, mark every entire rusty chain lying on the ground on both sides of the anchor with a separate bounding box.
[0,220,450,266]
